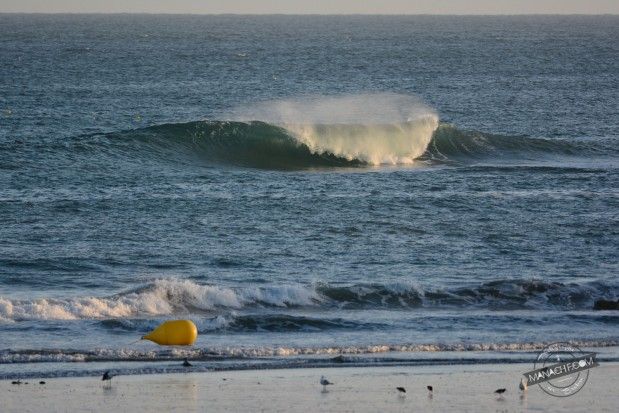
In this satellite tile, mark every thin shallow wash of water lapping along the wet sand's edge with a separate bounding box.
[0,346,619,381]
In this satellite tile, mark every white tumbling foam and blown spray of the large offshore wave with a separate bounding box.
[234,93,439,165]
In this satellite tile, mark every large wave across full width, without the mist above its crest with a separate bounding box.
[0,119,619,170]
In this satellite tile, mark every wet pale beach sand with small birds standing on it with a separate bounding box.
[0,363,619,412]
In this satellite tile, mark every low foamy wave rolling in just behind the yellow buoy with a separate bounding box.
[0,279,618,322]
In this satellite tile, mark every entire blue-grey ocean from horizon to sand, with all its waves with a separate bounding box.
[0,14,619,379]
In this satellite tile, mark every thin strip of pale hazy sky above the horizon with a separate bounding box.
[0,0,619,14]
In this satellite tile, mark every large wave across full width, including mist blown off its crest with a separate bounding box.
[2,94,619,170]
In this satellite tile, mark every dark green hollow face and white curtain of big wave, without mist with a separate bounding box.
[101,117,438,169]
